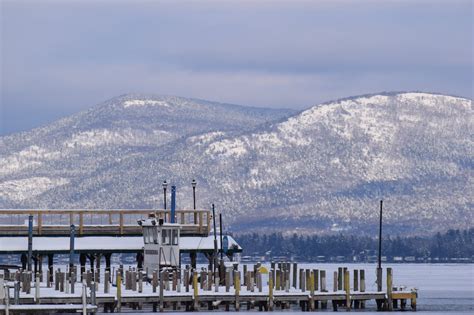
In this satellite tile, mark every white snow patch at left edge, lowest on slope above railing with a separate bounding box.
[0,177,69,201]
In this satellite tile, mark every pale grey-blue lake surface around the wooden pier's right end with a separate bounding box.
[105,264,474,315]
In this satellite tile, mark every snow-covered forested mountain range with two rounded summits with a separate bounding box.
[0,93,474,233]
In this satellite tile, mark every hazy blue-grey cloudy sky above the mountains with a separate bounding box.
[0,0,473,134]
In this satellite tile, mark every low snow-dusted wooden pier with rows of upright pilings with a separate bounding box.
[0,263,417,314]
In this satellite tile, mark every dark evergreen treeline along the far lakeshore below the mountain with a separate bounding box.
[236,228,474,259]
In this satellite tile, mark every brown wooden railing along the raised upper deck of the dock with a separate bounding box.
[0,209,211,236]
